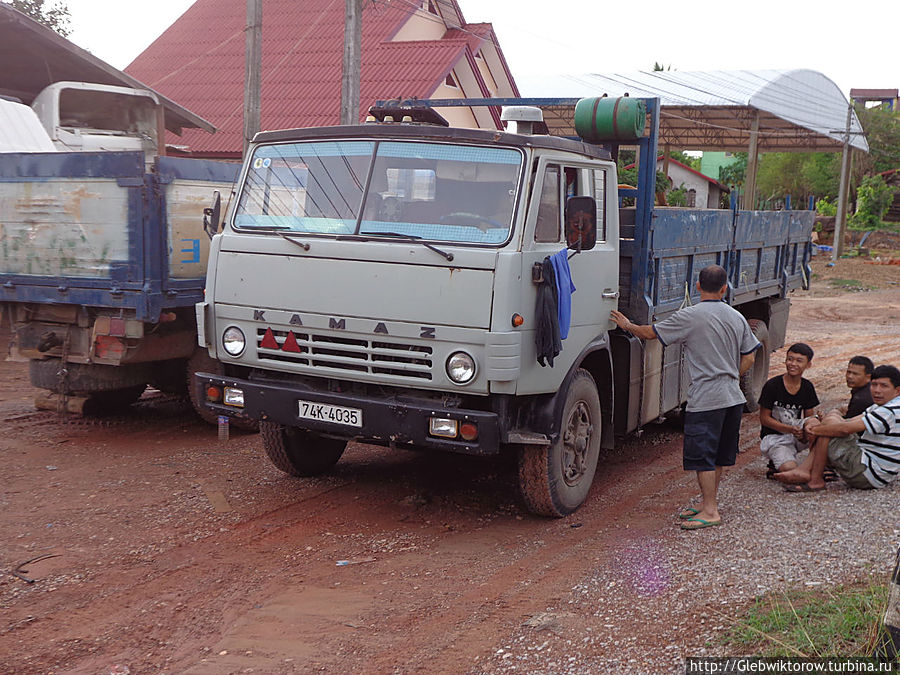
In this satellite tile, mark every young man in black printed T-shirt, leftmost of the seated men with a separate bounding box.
[759,342,819,477]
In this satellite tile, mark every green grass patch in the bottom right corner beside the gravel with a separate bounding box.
[721,580,888,657]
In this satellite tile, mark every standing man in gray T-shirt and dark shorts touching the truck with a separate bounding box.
[611,265,761,530]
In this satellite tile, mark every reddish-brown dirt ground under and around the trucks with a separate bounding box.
[0,261,900,675]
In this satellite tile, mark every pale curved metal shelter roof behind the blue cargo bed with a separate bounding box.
[516,70,869,152]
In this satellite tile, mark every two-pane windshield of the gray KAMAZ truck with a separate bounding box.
[234,141,522,244]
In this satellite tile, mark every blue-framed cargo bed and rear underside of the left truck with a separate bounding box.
[0,151,239,419]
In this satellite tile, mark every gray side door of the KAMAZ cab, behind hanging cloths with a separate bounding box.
[516,157,619,394]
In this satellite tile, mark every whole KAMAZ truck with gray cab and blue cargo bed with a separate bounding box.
[195,99,813,516]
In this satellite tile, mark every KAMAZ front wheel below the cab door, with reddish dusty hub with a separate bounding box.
[519,368,601,518]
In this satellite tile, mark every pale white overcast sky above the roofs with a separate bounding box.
[65,0,900,96]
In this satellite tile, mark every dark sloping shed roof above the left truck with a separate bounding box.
[0,3,216,134]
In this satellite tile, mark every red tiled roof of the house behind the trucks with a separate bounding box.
[126,0,506,154]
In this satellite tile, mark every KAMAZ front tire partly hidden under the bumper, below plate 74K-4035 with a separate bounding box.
[259,422,347,476]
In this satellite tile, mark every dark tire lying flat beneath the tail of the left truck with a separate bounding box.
[28,359,150,395]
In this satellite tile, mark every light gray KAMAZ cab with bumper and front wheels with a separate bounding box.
[196,108,619,515]
